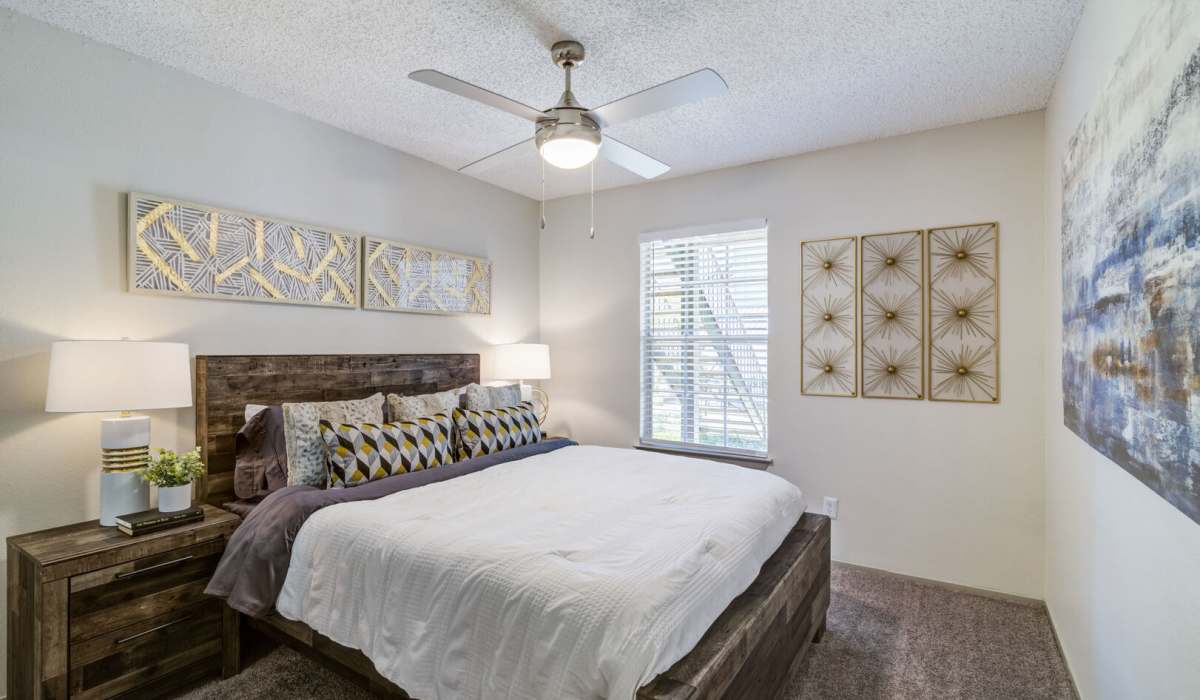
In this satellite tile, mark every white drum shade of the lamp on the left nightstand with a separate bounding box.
[46,340,192,413]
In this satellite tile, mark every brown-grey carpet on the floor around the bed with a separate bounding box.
[175,564,1075,700]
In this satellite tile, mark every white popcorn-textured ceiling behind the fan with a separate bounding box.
[0,0,1084,198]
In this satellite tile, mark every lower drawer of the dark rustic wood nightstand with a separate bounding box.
[70,598,223,698]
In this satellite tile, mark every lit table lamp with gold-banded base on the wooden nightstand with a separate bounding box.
[46,340,192,526]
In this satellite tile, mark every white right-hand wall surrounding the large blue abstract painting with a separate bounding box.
[1043,0,1200,699]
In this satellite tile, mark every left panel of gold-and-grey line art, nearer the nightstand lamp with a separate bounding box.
[128,192,359,309]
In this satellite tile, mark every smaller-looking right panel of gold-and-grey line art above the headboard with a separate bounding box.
[362,237,492,313]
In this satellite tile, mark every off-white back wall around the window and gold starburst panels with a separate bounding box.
[541,113,1044,598]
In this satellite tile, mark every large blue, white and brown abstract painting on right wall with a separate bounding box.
[1062,0,1200,522]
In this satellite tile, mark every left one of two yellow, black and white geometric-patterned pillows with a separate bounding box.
[320,413,454,489]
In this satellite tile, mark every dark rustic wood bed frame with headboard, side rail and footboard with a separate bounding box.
[196,354,830,700]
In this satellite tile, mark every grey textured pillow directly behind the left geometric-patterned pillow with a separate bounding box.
[283,394,384,487]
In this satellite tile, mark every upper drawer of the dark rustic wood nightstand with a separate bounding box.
[70,538,224,643]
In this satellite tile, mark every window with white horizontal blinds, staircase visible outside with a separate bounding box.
[641,220,767,457]
